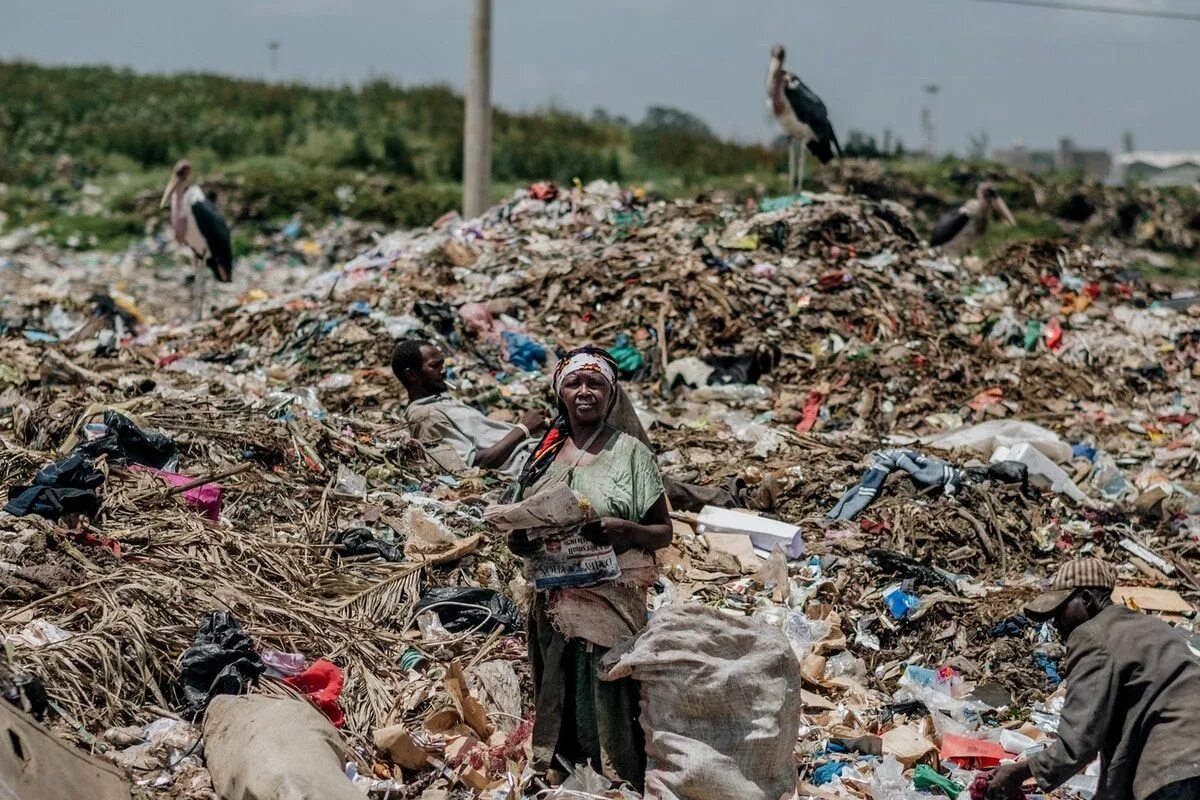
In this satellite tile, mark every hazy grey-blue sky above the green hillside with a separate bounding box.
[0,0,1200,152]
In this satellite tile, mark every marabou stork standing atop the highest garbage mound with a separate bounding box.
[767,44,841,194]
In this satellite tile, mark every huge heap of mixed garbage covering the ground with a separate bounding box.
[0,182,1200,799]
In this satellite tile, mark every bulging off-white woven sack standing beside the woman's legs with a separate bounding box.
[605,603,800,800]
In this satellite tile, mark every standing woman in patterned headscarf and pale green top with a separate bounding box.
[509,347,672,792]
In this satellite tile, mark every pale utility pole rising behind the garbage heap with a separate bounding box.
[462,0,492,219]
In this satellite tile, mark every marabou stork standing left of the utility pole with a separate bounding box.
[158,160,233,319]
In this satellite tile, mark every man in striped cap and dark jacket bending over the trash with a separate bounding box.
[985,558,1200,800]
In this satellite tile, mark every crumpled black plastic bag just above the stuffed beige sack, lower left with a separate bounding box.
[179,612,266,720]
